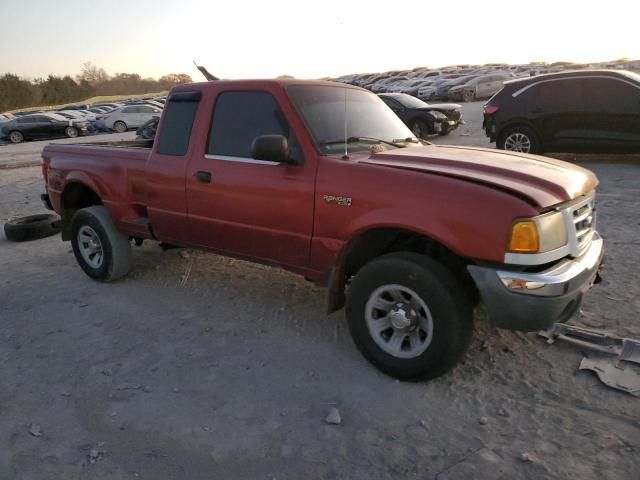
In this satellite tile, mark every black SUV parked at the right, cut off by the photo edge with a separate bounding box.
[483,70,640,153]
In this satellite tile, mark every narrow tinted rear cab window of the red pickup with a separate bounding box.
[158,92,202,155]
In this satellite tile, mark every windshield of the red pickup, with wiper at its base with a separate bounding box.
[287,85,413,154]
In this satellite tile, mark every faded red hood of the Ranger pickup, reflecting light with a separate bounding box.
[359,145,598,208]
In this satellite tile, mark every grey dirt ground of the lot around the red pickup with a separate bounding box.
[0,103,640,480]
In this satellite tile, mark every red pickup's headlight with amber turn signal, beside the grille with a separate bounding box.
[507,212,567,253]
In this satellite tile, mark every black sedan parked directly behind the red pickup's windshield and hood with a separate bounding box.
[378,93,463,138]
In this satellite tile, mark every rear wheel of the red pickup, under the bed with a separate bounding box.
[71,206,132,282]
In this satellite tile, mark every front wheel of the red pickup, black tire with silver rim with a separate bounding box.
[346,252,473,381]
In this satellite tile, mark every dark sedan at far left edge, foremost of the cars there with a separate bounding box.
[1,113,90,143]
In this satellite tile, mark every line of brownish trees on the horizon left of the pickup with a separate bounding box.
[0,62,193,112]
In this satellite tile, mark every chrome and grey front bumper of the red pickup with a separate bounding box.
[467,233,604,331]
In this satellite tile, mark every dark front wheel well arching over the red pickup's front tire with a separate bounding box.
[327,226,479,313]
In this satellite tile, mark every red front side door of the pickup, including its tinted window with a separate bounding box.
[186,91,315,266]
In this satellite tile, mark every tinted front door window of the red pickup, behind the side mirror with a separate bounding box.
[207,92,295,158]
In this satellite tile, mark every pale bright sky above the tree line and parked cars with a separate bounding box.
[0,0,640,80]
